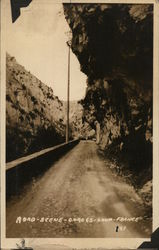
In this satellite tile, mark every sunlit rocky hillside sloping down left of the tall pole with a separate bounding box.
[6,54,65,161]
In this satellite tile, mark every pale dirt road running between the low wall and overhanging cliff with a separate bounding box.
[6,141,151,238]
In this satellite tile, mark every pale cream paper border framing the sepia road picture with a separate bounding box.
[0,0,159,249]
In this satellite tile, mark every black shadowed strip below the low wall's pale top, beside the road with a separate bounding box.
[6,142,78,200]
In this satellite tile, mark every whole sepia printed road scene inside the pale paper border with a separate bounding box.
[2,0,159,246]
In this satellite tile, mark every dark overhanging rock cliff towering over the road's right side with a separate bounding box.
[64,4,153,176]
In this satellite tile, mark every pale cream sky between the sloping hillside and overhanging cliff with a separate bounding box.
[6,0,86,100]
